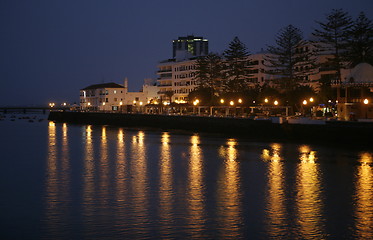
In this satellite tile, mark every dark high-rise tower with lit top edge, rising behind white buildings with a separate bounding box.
[172,35,209,58]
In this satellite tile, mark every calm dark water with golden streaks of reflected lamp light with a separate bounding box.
[0,117,373,239]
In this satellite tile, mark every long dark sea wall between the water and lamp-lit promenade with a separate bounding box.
[48,111,373,145]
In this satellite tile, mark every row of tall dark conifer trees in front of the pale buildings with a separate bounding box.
[192,9,373,104]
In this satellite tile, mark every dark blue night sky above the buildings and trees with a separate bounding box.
[0,0,373,106]
